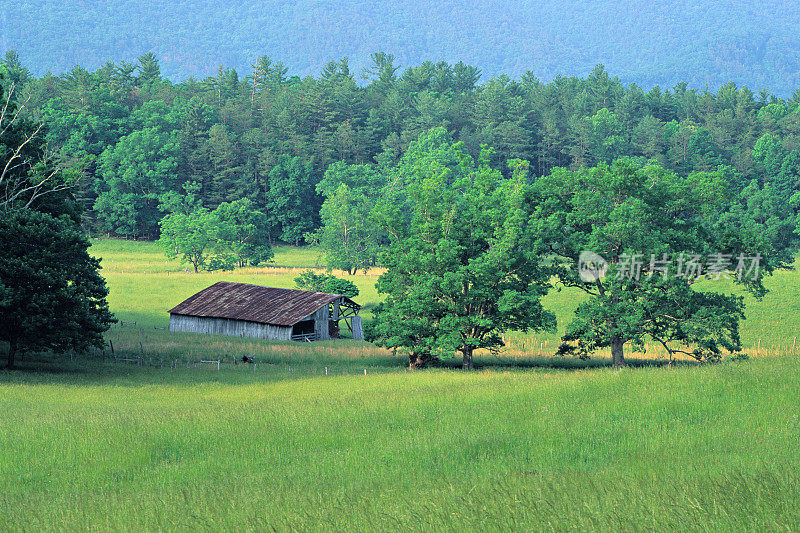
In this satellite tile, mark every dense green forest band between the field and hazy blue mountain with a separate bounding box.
[2,52,800,260]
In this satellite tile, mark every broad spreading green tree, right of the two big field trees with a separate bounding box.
[534,159,786,366]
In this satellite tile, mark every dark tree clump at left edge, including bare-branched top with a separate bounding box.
[0,78,114,368]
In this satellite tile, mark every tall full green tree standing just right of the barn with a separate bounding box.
[371,128,555,369]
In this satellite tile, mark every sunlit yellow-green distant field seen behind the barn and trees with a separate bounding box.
[91,239,800,359]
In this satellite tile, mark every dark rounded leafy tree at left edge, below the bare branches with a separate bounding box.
[0,209,113,368]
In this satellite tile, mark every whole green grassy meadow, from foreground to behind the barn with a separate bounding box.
[0,240,800,531]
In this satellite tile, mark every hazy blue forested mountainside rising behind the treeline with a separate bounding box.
[0,0,800,96]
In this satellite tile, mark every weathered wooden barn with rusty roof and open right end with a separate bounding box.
[169,281,364,341]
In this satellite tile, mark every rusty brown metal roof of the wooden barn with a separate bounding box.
[169,281,358,326]
